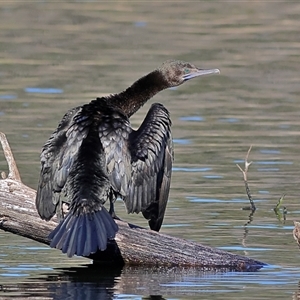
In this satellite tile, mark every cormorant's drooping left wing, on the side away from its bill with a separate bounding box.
[36,107,91,220]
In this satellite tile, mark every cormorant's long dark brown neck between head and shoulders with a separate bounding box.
[110,70,169,118]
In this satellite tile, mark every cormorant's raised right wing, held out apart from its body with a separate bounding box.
[124,103,173,231]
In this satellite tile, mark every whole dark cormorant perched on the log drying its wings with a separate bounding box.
[36,61,219,257]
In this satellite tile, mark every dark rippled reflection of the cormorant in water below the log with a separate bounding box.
[0,265,121,300]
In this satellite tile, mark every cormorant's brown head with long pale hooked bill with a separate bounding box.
[159,60,220,87]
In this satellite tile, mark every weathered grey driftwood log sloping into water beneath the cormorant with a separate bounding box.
[0,133,265,271]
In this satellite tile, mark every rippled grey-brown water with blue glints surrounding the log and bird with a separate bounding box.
[0,1,300,299]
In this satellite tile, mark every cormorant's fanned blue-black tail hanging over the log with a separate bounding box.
[49,207,118,257]
